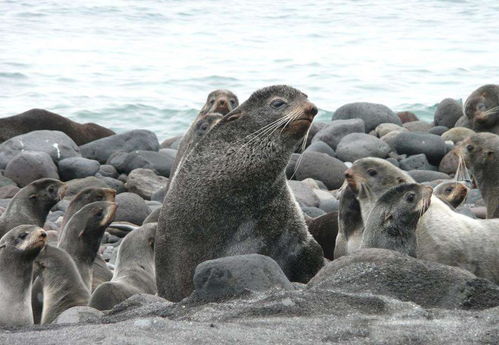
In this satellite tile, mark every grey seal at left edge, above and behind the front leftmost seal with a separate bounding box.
[0,178,66,238]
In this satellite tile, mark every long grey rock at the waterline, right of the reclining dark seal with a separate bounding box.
[80,129,159,164]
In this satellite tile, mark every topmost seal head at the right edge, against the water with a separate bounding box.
[464,84,499,134]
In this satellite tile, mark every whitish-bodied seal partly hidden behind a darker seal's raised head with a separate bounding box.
[345,158,499,283]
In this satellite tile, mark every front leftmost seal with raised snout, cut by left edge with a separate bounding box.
[0,225,47,326]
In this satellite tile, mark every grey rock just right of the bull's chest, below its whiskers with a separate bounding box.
[295,152,347,189]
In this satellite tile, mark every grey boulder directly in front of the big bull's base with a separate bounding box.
[190,254,294,302]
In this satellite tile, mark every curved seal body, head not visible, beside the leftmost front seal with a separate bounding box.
[35,245,90,325]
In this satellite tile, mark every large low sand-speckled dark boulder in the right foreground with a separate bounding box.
[308,249,499,309]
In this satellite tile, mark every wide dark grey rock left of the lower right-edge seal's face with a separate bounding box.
[393,131,447,165]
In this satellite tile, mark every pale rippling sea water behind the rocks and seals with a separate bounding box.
[0,0,499,140]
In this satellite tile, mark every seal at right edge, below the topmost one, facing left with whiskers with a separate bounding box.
[456,133,499,218]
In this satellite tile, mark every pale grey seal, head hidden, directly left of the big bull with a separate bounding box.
[88,223,157,310]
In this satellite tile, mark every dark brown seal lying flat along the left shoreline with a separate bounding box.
[0,109,116,146]
